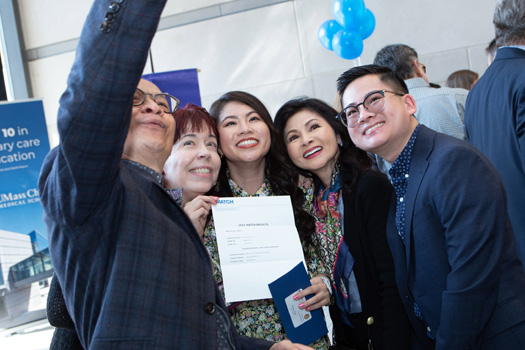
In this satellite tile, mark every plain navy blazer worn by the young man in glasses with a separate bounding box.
[387,125,525,350]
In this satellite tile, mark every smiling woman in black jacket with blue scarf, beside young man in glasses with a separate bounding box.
[275,98,410,350]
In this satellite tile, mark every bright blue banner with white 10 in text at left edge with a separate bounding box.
[0,100,49,251]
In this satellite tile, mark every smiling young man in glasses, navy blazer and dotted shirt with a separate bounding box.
[337,65,525,350]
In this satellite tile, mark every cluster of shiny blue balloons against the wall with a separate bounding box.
[318,0,376,60]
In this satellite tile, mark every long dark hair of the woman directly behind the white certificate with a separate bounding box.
[210,91,315,252]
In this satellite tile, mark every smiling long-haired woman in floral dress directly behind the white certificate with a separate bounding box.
[208,91,330,349]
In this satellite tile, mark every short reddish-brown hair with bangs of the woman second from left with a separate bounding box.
[173,103,219,143]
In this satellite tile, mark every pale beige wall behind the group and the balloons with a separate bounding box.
[19,0,496,146]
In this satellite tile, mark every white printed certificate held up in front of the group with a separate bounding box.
[212,196,306,303]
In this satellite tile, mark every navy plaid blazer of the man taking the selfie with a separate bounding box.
[39,0,271,350]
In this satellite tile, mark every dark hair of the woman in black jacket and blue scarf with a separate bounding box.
[275,97,371,194]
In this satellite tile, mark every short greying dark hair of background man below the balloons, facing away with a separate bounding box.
[374,44,418,80]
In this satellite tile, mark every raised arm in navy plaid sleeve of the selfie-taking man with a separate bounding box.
[39,0,165,224]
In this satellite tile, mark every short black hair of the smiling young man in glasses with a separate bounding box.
[337,64,408,106]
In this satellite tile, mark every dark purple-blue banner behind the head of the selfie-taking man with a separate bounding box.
[142,68,202,108]
